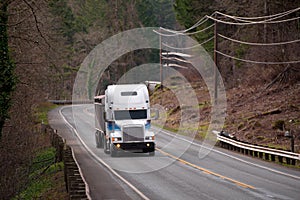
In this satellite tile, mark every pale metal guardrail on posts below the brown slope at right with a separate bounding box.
[213,131,300,165]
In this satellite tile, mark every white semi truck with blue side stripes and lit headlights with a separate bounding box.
[94,84,158,157]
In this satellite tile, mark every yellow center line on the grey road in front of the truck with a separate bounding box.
[156,148,255,189]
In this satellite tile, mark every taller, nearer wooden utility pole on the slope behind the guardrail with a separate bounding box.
[214,13,218,105]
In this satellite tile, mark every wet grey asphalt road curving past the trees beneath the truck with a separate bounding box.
[49,105,300,199]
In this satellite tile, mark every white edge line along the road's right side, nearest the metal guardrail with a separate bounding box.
[155,128,300,179]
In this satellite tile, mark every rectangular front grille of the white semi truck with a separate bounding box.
[123,126,144,142]
